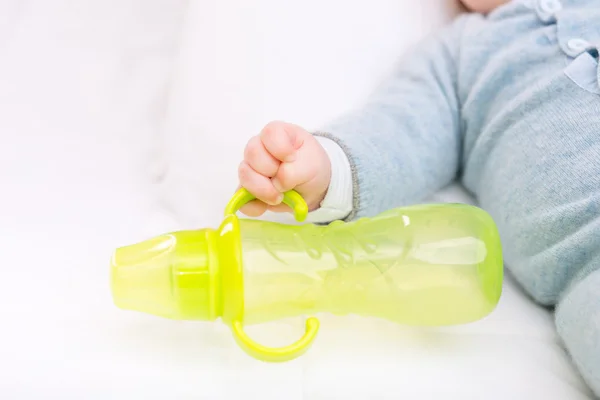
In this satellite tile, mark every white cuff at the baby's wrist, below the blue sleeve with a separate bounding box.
[306,136,353,223]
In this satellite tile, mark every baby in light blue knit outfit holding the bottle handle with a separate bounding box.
[239,0,600,395]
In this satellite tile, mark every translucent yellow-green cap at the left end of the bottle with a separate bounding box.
[110,230,217,320]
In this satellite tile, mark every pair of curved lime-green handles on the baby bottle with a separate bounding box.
[225,188,319,362]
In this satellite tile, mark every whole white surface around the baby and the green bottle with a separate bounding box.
[0,0,588,400]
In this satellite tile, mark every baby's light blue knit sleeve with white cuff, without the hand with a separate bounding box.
[311,19,463,222]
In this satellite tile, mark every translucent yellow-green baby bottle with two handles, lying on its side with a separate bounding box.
[111,189,503,361]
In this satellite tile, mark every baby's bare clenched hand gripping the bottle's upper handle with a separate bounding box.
[238,122,331,217]
